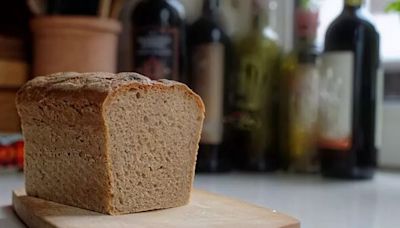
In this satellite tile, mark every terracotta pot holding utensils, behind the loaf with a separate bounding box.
[31,16,121,76]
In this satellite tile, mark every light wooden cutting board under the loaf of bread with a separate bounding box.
[12,190,300,228]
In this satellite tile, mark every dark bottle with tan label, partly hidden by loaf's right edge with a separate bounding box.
[188,0,230,172]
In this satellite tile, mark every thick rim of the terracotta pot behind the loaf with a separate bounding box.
[30,16,122,33]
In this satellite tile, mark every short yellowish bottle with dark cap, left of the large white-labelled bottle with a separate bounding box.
[281,50,319,173]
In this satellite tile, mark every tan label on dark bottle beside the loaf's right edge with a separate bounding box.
[192,43,225,144]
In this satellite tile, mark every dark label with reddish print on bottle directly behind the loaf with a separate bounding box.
[133,27,179,81]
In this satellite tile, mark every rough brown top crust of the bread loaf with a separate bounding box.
[16,72,205,113]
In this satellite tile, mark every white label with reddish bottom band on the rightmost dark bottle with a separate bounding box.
[318,51,354,150]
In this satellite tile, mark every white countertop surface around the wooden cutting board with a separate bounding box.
[0,171,400,228]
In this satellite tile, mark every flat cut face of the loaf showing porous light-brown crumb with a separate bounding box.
[104,79,203,214]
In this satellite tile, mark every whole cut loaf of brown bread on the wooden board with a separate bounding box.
[17,73,204,214]
